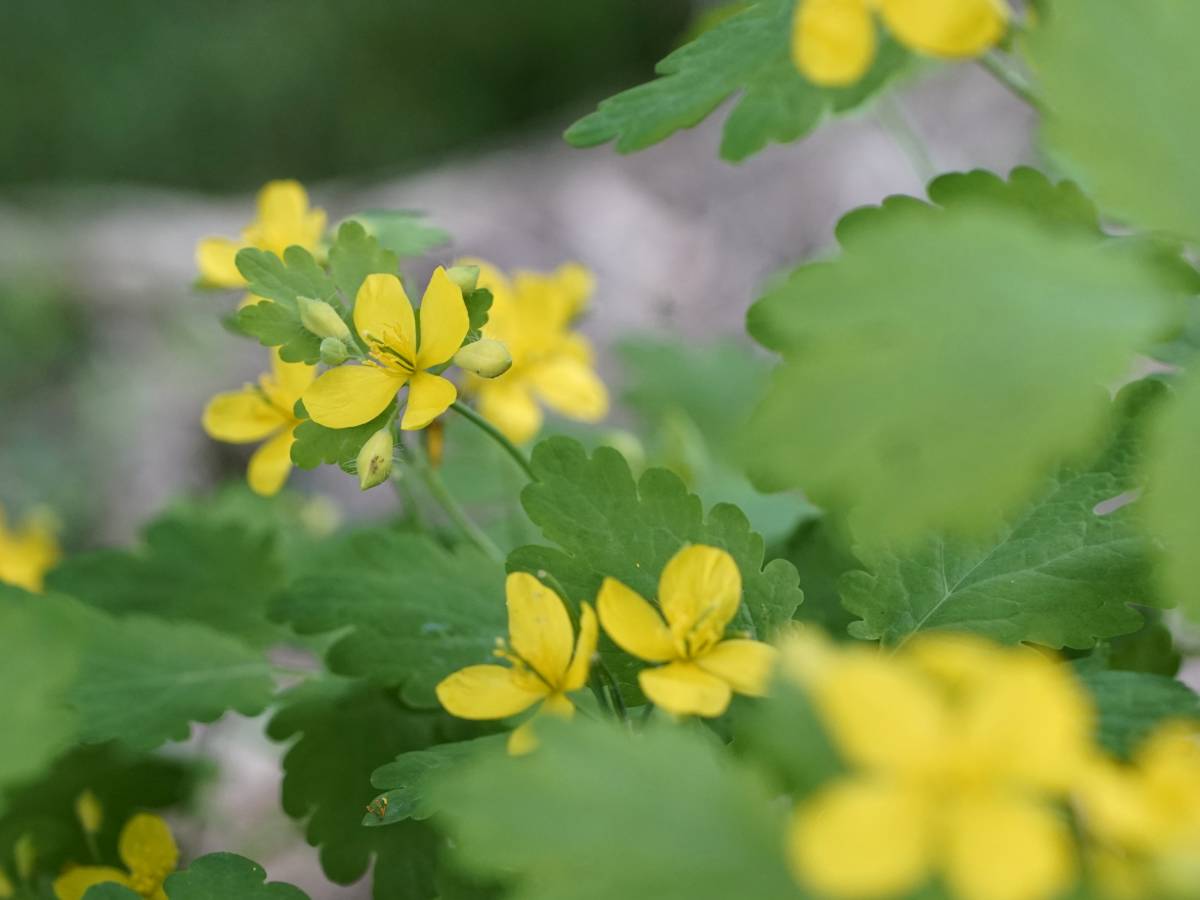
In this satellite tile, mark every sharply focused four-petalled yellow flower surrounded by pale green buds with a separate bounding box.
[304,265,470,430]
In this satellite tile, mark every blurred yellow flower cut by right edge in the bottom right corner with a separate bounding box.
[1079,722,1200,900]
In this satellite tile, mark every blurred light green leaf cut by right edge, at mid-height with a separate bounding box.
[1145,371,1200,620]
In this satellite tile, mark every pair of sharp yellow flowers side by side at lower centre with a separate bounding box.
[437,545,775,754]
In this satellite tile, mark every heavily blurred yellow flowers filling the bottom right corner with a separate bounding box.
[781,635,1200,900]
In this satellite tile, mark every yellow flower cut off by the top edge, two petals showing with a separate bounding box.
[792,0,1008,85]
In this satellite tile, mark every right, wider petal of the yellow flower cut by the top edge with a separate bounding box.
[880,0,1008,59]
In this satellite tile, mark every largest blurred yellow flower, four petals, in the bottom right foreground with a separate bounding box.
[784,636,1093,900]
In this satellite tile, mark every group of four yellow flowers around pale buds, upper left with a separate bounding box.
[196,181,608,496]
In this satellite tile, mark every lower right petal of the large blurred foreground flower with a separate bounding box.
[943,793,1075,900]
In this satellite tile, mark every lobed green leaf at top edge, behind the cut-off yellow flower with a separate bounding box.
[565,0,906,162]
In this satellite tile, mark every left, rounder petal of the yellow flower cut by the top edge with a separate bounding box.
[792,0,875,86]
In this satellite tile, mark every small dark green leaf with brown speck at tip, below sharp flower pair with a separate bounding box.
[362,734,508,827]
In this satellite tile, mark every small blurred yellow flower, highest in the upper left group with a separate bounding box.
[196,181,325,292]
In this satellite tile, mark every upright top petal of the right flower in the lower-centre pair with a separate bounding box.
[659,544,742,649]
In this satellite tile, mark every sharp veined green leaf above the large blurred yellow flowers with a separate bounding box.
[840,383,1163,649]
